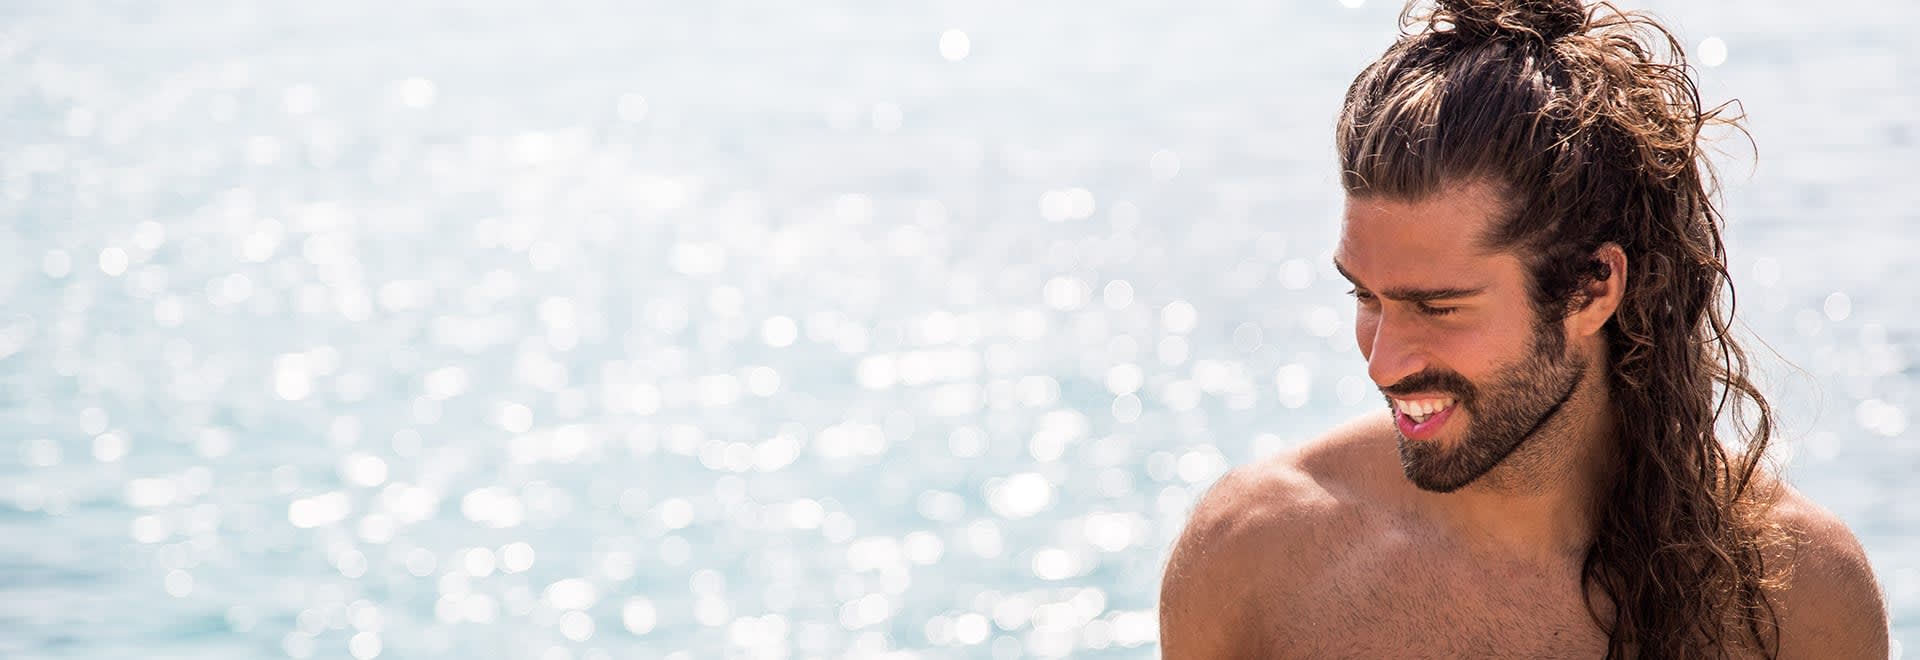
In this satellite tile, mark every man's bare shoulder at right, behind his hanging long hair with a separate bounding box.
[1768,485,1887,658]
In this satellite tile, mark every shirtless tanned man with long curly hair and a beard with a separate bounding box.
[1160,0,1887,660]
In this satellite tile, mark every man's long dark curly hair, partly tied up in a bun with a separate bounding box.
[1336,0,1784,658]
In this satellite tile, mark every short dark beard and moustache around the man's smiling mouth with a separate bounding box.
[1380,322,1586,493]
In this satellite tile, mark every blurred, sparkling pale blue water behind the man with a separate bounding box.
[0,0,1920,660]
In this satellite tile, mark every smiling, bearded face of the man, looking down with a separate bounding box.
[1334,186,1586,493]
